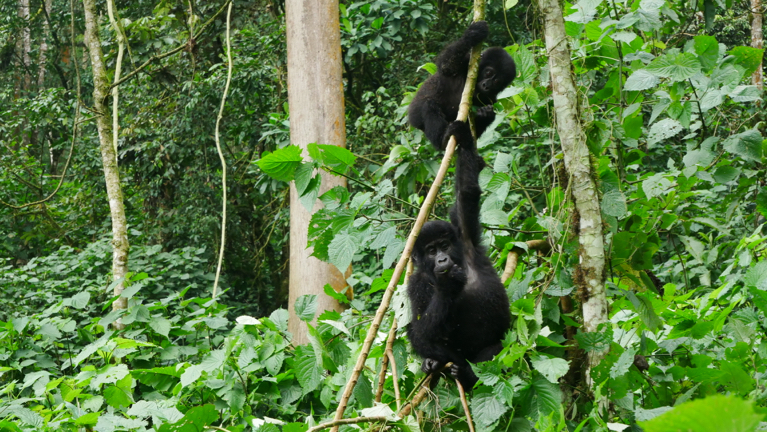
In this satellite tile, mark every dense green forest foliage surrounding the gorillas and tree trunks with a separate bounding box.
[0,0,767,431]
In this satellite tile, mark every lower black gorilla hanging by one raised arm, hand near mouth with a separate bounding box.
[407,121,511,390]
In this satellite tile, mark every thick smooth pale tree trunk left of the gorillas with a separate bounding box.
[285,0,346,345]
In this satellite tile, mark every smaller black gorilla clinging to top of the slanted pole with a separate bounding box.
[408,21,517,150]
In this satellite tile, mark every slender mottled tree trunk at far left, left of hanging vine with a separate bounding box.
[83,0,129,329]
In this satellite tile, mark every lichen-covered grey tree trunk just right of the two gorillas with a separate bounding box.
[538,0,607,384]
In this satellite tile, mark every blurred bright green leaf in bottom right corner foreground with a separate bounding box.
[639,395,761,432]
